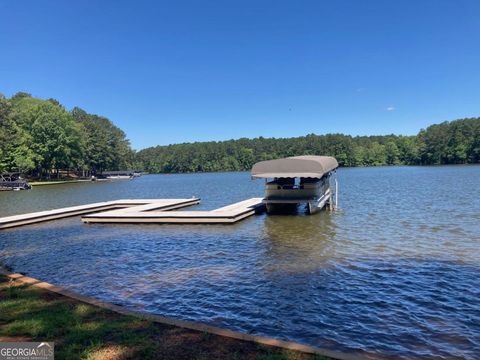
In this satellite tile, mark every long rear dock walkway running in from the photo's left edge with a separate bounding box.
[0,198,200,229]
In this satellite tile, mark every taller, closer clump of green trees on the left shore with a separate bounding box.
[0,92,135,178]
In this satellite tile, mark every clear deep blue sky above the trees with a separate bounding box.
[0,0,480,149]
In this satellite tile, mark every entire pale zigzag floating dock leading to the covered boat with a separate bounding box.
[0,198,265,229]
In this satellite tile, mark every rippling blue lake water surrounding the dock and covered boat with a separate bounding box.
[0,166,480,359]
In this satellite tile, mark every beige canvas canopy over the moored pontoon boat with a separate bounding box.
[251,155,338,179]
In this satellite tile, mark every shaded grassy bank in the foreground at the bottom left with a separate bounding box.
[0,275,327,360]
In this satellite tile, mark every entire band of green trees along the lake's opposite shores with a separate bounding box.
[0,92,480,178]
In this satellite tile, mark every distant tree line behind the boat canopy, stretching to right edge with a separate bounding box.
[136,118,480,173]
